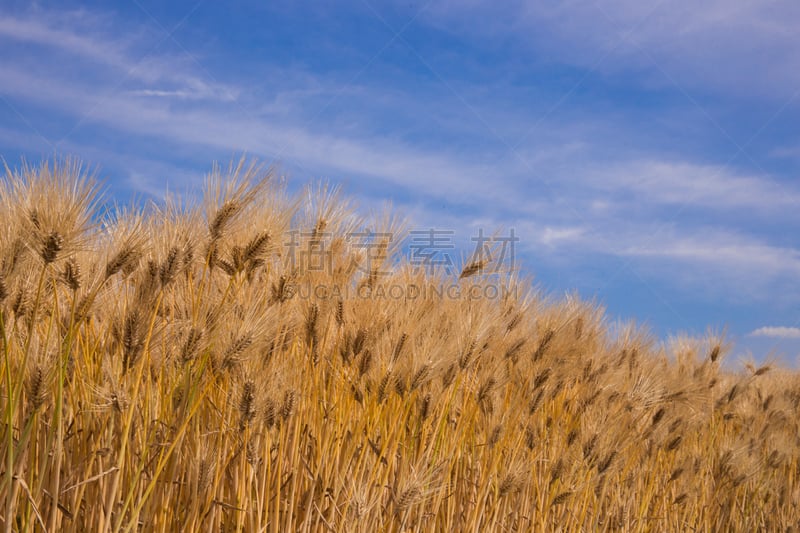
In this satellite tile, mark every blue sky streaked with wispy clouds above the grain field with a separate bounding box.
[0,0,800,365]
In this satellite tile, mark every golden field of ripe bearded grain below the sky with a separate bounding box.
[0,160,800,532]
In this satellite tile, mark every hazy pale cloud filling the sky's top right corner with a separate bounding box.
[423,0,800,99]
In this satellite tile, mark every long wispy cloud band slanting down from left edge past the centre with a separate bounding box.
[0,54,521,207]
